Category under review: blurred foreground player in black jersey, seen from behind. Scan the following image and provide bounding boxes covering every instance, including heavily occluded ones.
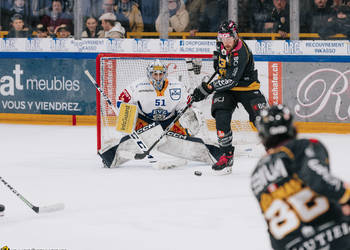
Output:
[251,105,350,250]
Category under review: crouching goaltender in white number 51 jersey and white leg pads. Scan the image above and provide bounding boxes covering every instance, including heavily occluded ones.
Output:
[99,59,218,168]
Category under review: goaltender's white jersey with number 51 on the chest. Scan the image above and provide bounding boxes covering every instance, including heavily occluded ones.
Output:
[119,77,189,121]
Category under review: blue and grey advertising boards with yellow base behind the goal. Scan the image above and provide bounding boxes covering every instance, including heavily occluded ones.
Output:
[0,41,350,133]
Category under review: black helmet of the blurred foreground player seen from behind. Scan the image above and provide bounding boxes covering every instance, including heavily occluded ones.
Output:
[255,104,296,148]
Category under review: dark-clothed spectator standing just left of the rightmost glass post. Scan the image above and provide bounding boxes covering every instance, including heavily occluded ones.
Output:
[272,0,289,38]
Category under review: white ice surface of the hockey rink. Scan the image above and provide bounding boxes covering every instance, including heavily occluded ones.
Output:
[0,124,350,250]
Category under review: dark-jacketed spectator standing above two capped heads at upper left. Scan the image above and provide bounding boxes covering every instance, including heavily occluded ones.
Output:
[41,0,73,34]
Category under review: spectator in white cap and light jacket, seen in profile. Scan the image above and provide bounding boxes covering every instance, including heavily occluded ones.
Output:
[98,13,125,38]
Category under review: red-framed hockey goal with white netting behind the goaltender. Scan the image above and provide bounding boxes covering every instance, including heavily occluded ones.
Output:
[96,53,254,150]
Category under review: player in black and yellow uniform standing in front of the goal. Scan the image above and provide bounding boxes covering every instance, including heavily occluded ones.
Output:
[192,21,266,174]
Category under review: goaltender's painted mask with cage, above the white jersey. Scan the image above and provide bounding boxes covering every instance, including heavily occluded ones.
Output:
[147,59,167,91]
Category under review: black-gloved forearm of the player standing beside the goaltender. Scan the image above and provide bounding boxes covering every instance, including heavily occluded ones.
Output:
[192,75,238,102]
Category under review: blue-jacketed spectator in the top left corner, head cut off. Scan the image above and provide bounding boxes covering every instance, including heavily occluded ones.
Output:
[1,0,35,30]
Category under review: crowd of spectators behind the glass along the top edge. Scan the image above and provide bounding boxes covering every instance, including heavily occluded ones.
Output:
[0,0,350,39]
